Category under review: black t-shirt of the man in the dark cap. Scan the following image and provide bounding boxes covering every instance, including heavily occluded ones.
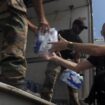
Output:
[59,30,82,59]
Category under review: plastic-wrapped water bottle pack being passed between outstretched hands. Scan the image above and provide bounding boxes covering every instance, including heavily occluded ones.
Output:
[34,28,58,55]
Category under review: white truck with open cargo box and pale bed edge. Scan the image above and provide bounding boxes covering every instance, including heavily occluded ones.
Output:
[0,0,94,105]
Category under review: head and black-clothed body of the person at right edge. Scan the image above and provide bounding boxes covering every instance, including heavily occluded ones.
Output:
[84,24,105,105]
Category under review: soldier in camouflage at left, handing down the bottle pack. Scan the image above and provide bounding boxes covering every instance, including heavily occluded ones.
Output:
[0,0,49,88]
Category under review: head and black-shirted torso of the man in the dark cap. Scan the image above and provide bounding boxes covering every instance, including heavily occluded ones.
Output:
[59,18,87,59]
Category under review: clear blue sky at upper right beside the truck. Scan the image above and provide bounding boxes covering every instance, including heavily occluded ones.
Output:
[92,0,105,38]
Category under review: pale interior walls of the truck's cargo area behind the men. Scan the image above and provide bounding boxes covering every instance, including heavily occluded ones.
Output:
[27,0,93,105]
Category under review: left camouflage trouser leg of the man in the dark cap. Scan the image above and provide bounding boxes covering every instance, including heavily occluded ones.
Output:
[41,61,61,101]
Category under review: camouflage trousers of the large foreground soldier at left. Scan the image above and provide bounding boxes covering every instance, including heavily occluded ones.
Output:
[0,9,28,87]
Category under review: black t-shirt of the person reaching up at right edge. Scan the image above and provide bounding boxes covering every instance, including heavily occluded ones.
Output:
[87,56,105,91]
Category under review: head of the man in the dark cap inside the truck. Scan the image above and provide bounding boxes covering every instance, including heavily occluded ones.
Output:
[72,18,87,34]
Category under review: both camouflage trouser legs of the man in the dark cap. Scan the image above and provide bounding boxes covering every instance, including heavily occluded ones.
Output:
[41,61,79,105]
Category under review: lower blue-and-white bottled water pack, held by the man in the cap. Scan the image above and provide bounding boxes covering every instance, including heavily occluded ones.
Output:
[60,69,83,89]
